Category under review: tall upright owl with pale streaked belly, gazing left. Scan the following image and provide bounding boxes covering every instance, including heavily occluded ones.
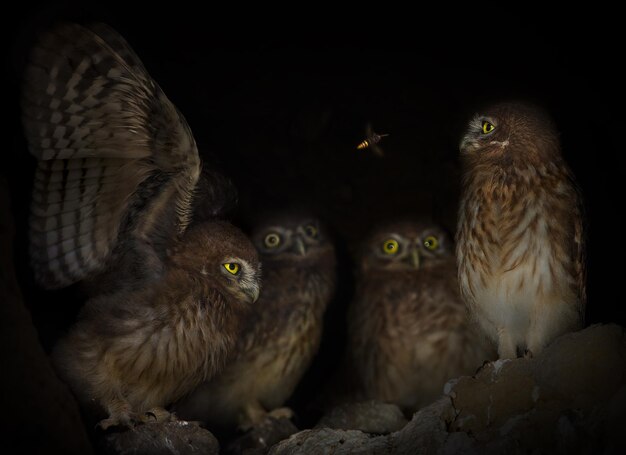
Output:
[456,103,586,358]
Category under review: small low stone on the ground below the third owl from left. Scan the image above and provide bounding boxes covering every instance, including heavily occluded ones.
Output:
[316,401,407,434]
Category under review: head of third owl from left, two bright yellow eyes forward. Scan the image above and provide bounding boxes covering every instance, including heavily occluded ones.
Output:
[360,221,454,272]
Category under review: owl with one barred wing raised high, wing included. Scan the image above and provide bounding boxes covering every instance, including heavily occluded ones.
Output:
[22,24,260,428]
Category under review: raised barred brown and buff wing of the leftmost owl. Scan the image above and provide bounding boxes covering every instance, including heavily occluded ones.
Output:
[22,24,200,288]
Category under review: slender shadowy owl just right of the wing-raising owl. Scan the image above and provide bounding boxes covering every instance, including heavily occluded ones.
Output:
[177,212,335,428]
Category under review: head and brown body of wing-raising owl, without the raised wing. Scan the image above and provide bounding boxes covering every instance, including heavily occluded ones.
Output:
[53,222,259,426]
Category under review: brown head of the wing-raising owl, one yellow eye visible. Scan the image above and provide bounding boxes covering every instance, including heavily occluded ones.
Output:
[170,221,261,303]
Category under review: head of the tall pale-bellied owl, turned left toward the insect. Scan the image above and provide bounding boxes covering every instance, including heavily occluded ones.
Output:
[459,102,559,161]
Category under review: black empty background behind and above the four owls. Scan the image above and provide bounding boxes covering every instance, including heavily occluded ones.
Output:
[2,2,626,434]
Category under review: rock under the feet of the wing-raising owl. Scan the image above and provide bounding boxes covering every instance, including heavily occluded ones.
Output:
[101,420,220,455]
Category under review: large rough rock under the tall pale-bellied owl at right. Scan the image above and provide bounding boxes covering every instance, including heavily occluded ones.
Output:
[449,325,626,452]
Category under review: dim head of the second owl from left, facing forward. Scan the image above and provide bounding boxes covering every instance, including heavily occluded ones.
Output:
[252,212,332,264]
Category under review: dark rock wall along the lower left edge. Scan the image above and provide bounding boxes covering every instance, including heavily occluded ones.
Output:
[0,178,92,455]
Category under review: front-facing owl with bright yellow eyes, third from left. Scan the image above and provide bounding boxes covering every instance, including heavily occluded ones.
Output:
[348,220,495,413]
